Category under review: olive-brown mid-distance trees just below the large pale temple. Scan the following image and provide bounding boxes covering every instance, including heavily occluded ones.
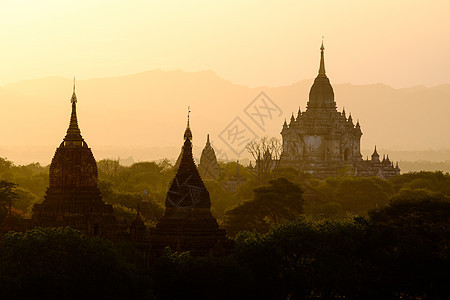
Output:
[222,169,450,235]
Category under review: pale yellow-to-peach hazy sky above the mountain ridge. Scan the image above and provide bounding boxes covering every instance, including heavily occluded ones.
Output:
[0,0,450,87]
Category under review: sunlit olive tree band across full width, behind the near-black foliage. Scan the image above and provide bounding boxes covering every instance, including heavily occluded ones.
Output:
[0,158,450,229]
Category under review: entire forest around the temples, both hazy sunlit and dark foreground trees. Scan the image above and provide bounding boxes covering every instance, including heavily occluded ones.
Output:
[0,158,450,299]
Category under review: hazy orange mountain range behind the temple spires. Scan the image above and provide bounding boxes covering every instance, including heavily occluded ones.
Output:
[0,70,450,164]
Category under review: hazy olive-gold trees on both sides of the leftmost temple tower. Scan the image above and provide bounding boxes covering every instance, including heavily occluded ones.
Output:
[0,158,175,223]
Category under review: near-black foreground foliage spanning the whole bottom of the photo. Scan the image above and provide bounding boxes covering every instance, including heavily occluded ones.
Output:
[0,196,450,299]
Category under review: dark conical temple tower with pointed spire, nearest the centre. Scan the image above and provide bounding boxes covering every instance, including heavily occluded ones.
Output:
[150,117,232,256]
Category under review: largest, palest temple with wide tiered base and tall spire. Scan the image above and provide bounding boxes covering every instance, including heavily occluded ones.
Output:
[280,43,399,178]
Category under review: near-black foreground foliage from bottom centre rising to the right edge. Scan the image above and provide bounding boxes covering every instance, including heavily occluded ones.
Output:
[152,198,450,299]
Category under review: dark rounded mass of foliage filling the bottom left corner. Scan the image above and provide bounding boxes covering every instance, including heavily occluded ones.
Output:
[0,227,152,299]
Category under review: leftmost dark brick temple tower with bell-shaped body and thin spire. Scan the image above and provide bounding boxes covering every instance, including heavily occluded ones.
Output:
[32,83,118,237]
